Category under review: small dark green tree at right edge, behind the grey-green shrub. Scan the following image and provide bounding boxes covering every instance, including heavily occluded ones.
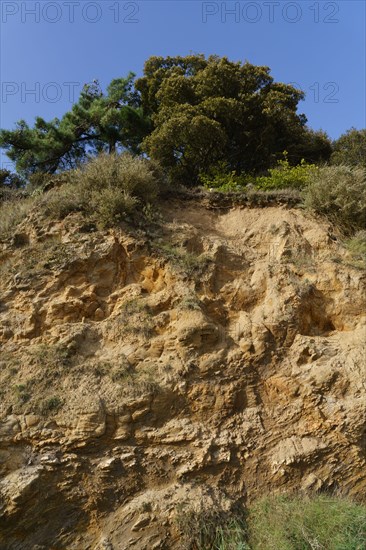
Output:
[331,128,366,168]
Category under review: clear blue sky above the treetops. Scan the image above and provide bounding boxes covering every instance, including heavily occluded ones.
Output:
[0,0,366,168]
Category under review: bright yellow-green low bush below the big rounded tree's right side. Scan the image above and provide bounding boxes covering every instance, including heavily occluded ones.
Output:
[255,151,318,191]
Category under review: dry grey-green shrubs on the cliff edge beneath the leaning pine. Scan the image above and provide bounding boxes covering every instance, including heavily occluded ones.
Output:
[0,152,164,239]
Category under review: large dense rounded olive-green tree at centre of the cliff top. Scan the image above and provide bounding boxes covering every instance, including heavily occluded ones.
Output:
[135,55,331,184]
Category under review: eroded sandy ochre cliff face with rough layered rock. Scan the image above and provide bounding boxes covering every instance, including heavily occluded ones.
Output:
[0,201,366,550]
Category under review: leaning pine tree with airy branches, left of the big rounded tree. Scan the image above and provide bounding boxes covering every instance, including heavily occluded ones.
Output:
[0,73,150,176]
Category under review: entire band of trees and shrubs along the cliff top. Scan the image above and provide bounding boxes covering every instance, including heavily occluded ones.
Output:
[0,54,366,244]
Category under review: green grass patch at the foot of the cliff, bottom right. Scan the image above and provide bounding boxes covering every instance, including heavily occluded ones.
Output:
[178,495,366,550]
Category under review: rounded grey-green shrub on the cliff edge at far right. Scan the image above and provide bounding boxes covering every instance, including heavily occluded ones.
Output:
[304,165,366,234]
